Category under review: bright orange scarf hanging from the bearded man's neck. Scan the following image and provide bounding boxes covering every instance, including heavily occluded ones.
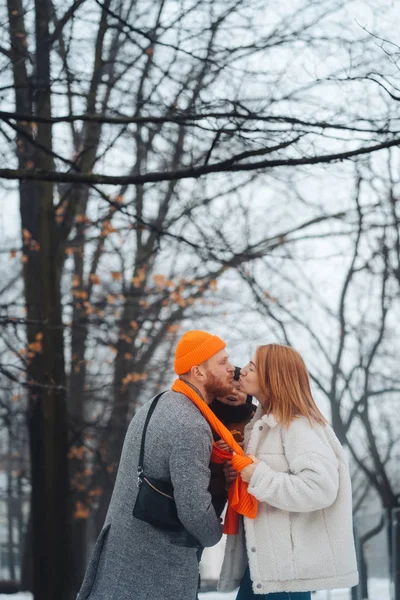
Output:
[172,379,258,534]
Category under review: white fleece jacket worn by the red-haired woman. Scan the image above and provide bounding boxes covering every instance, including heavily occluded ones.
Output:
[219,407,358,594]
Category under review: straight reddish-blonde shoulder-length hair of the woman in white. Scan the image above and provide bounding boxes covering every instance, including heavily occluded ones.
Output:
[255,344,327,426]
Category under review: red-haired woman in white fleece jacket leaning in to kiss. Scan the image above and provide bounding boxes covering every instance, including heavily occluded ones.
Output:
[219,344,358,600]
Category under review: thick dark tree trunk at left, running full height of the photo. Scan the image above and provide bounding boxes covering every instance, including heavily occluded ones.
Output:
[20,0,68,600]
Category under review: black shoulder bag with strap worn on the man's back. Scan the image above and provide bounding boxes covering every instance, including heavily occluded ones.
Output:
[132,392,183,532]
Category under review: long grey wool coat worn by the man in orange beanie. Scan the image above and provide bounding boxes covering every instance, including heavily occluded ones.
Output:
[77,391,222,600]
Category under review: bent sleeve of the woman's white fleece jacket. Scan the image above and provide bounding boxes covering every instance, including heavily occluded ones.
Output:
[248,422,339,512]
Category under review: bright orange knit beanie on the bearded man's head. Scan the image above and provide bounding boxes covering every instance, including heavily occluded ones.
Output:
[174,330,226,375]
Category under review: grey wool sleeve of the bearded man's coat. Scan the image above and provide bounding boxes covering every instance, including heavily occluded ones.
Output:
[170,422,222,547]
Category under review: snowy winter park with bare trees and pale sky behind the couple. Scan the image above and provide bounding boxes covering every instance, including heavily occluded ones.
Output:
[0,0,400,600]
